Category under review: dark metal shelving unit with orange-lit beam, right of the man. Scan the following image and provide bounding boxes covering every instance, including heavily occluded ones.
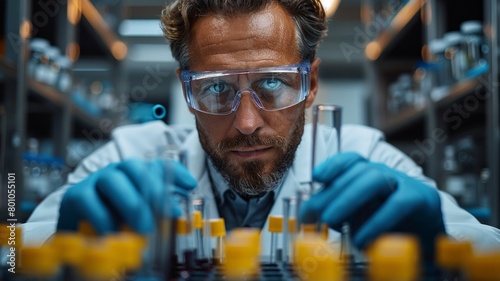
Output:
[365,0,500,226]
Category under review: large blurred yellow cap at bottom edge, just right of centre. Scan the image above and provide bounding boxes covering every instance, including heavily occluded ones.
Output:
[293,232,345,281]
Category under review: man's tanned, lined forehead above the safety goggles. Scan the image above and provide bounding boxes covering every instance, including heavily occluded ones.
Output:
[189,4,296,70]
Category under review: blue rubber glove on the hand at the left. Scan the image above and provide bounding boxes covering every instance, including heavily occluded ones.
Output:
[57,159,197,234]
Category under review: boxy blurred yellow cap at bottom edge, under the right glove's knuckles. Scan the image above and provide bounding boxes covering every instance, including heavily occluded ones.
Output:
[367,234,420,281]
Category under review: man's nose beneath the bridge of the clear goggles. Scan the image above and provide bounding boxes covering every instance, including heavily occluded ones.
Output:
[233,92,264,135]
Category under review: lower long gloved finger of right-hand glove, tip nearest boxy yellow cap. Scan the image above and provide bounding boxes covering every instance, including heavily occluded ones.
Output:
[353,186,427,249]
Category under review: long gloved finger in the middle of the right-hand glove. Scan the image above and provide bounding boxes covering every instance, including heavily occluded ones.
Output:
[320,167,396,229]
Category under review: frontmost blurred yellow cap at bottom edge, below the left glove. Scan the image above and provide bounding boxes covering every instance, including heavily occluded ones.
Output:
[78,240,119,280]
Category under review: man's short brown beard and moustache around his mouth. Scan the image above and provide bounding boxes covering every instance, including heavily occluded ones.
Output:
[196,111,305,198]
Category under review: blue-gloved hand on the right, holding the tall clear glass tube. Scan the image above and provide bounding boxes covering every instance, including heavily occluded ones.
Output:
[301,153,445,259]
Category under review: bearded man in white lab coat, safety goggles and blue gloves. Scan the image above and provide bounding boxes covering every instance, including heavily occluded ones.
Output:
[25,0,500,258]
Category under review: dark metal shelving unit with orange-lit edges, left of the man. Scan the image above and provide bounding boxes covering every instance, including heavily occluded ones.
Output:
[0,0,123,219]
